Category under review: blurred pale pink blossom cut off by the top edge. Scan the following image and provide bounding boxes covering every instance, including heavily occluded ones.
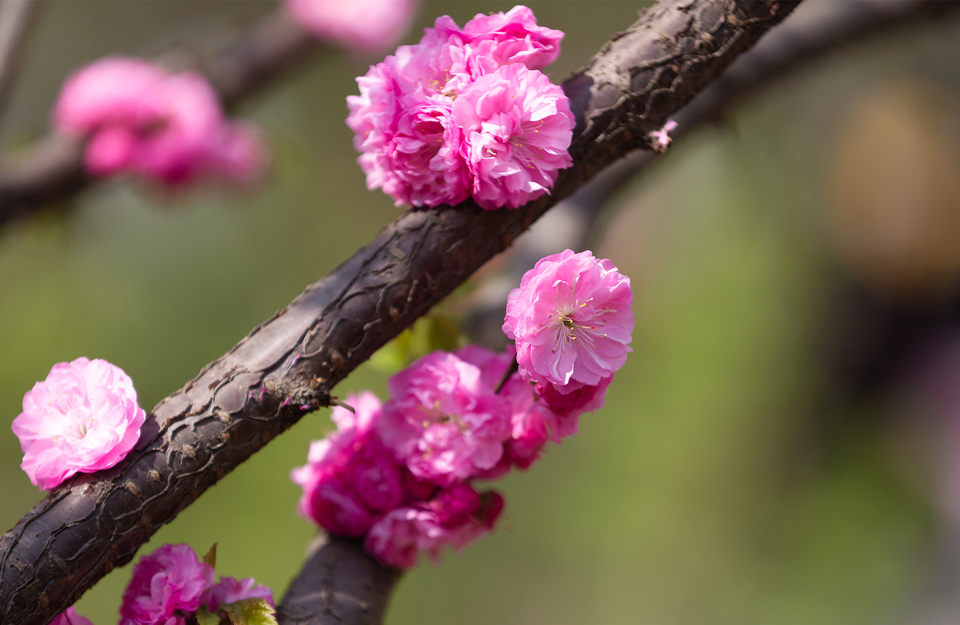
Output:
[286,0,417,52]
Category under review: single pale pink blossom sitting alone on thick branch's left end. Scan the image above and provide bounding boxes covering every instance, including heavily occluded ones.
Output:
[12,358,146,490]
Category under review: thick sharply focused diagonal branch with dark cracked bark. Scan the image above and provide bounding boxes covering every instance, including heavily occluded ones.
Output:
[0,0,796,624]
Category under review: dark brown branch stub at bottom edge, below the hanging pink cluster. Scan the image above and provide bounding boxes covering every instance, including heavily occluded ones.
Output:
[277,535,401,625]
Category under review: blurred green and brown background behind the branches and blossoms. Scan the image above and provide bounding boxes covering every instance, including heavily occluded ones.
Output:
[0,0,960,625]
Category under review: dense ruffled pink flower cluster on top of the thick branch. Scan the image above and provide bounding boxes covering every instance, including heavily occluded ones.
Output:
[347,6,574,209]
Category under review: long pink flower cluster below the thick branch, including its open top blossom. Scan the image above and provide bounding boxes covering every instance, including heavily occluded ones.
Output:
[291,250,633,568]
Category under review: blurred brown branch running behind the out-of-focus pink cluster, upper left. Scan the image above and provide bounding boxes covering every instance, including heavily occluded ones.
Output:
[0,6,322,226]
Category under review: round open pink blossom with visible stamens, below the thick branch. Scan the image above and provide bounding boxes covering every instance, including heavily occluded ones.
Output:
[503,250,634,394]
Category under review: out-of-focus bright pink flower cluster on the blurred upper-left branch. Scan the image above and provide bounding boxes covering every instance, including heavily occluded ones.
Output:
[53,57,265,185]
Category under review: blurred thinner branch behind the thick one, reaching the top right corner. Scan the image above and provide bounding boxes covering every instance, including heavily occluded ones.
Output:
[462,0,960,349]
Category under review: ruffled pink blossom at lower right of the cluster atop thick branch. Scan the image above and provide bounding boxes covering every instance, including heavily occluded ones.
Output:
[453,63,574,209]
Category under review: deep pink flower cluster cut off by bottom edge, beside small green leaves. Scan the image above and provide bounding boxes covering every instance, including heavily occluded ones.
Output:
[120,544,274,625]
